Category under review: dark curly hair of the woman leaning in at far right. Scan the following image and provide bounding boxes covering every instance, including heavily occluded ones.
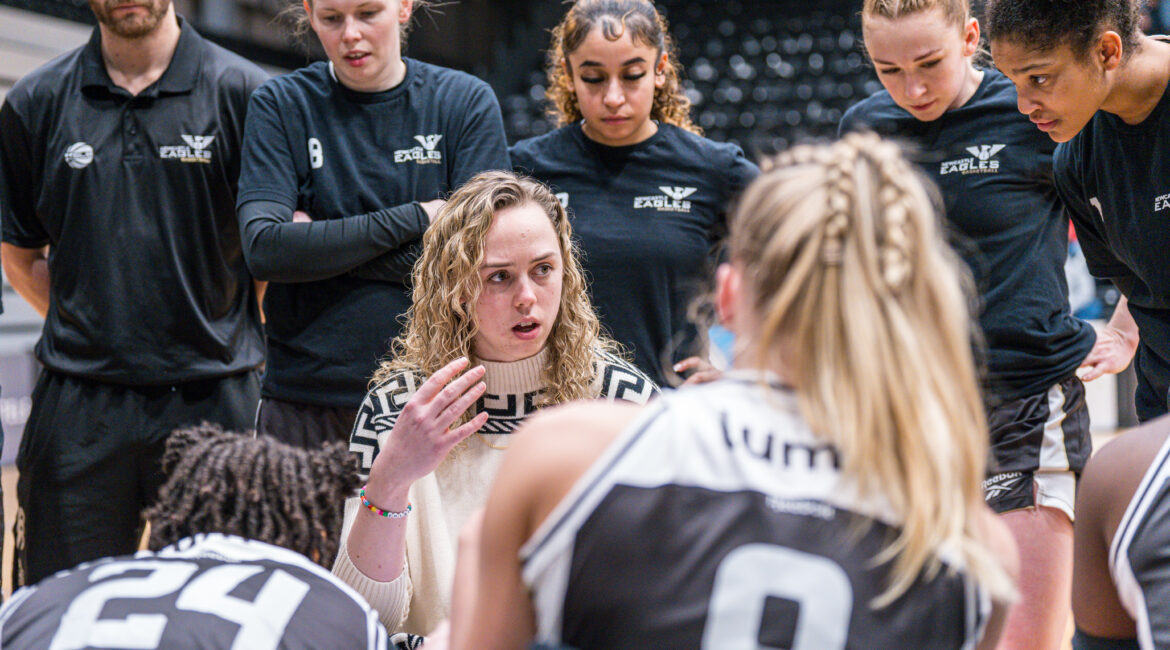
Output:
[984,0,1143,57]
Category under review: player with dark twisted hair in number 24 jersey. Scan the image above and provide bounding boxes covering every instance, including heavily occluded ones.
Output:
[0,426,387,650]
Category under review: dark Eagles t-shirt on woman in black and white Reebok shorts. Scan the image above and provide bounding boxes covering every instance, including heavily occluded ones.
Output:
[840,70,1096,403]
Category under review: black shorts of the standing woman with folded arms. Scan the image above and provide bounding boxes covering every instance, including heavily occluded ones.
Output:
[256,397,358,449]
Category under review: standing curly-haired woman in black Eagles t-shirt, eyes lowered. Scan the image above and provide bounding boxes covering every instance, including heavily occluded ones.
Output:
[510,0,759,383]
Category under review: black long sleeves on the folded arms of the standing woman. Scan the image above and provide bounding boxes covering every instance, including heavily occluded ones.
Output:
[238,200,431,283]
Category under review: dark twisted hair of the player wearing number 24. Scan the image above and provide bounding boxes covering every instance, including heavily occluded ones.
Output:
[145,422,360,568]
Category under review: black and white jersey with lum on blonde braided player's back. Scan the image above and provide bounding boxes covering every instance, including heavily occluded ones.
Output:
[521,373,990,650]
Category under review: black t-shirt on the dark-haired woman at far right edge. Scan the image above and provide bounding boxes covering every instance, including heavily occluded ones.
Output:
[1055,81,1170,421]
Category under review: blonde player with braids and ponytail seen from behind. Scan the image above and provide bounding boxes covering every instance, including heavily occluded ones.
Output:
[452,133,1016,649]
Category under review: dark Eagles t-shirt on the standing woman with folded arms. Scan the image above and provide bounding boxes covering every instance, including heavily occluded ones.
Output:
[239,58,510,408]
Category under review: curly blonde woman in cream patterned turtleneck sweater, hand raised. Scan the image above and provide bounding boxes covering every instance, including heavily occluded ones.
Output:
[333,172,656,634]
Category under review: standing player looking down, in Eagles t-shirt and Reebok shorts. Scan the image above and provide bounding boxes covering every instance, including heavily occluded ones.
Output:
[840,0,1095,648]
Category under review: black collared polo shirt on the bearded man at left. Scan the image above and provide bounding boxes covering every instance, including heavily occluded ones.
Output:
[0,19,267,385]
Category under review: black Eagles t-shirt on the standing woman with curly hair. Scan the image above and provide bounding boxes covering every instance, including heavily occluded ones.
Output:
[511,124,759,386]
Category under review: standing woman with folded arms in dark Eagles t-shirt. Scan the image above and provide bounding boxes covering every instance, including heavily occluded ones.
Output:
[238,0,510,445]
